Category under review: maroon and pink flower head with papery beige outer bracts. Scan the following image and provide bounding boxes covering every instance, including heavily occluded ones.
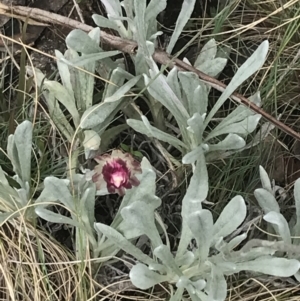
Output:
[92,150,142,196]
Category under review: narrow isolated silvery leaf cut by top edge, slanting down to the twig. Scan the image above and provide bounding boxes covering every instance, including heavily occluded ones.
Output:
[166,0,196,53]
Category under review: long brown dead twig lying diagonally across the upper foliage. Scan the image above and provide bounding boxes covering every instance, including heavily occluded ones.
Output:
[0,3,300,141]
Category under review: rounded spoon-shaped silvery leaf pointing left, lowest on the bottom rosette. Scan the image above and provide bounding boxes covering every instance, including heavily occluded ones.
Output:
[129,263,168,290]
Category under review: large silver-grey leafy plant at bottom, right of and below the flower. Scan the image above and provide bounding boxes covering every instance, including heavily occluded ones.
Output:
[95,154,300,301]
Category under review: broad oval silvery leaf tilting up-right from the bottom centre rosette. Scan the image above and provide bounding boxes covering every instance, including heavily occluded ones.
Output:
[213,195,247,242]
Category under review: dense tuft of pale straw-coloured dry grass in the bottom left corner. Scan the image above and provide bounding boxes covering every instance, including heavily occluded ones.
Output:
[0,219,85,301]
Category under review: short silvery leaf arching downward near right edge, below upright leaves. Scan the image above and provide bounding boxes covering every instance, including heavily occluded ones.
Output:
[264,211,291,244]
